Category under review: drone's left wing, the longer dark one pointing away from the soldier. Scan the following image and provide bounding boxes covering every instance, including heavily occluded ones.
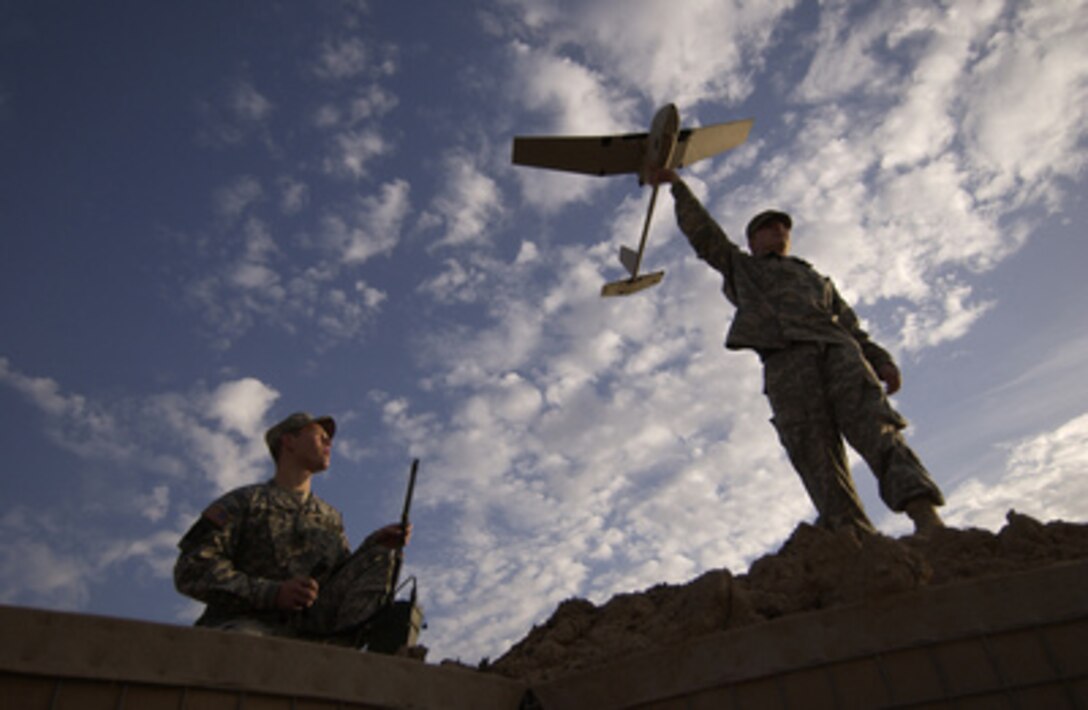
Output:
[514,133,647,175]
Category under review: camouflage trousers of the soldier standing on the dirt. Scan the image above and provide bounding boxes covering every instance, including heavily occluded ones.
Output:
[763,342,944,530]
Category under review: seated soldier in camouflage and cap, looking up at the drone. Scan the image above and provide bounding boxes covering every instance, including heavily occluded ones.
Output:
[174,412,411,637]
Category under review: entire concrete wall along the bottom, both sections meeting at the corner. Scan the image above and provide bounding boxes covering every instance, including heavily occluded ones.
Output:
[0,562,1088,710]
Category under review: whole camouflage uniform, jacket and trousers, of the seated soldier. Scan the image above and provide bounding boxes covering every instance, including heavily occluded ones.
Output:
[174,482,393,636]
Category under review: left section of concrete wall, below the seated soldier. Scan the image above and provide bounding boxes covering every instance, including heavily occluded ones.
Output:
[0,607,524,710]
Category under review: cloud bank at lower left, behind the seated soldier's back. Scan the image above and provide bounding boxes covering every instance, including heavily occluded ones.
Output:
[0,359,280,609]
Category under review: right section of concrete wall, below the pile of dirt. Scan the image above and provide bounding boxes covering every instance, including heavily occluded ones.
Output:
[533,562,1088,710]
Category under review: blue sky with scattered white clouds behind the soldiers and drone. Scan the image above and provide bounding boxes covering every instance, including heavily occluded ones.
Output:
[0,0,1088,664]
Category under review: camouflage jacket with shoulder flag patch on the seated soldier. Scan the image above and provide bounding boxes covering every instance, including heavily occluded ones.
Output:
[174,482,350,623]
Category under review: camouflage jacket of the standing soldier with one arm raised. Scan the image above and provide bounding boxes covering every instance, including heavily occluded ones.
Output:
[672,179,892,369]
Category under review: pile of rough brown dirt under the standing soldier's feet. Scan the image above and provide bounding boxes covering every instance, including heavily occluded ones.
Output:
[481,511,1088,683]
